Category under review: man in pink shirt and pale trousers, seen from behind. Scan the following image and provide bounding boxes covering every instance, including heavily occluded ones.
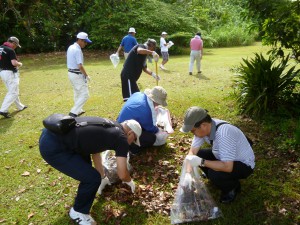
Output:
[189,32,203,75]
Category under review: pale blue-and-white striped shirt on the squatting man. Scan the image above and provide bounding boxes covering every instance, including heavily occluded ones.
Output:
[192,119,255,169]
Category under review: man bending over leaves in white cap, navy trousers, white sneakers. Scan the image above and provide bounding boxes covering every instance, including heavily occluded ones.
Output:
[39,117,142,225]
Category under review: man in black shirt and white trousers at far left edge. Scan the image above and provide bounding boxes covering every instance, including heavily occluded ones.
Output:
[0,37,27,118]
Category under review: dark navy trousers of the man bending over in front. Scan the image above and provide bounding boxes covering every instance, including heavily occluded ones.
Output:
[39,129,101,214]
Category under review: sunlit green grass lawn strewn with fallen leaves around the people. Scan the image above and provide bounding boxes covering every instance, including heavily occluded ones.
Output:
[0,43,300,225]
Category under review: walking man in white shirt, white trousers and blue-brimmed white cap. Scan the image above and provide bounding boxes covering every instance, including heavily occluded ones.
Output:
[67,32,92,117]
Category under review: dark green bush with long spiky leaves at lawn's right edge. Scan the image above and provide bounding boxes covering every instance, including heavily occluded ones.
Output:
[234,53,300,117]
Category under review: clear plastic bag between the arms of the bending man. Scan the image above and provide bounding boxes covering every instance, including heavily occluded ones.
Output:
[101,150,132,184]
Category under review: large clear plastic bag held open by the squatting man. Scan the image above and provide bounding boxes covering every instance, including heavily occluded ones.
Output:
[170,161,222,224]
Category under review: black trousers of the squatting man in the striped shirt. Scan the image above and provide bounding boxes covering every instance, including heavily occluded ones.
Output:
[197,149,253,193]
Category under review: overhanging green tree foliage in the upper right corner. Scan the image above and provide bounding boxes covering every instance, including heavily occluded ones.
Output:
[245,0,300,60]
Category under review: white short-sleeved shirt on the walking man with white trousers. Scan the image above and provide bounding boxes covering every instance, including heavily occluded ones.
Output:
[67,42,83,70]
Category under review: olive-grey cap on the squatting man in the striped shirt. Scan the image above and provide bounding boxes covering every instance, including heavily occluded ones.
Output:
[180,106,207,133]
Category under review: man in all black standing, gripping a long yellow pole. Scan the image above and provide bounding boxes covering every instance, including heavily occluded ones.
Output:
[121,39,160,102]
